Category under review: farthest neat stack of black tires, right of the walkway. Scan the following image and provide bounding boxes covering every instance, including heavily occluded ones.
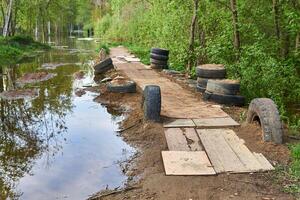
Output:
[150,48,170,69]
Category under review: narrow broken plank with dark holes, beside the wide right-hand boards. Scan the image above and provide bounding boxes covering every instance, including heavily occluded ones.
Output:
[183,128,204,151]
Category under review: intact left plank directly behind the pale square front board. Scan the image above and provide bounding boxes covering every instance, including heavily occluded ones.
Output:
[165,128,191,151]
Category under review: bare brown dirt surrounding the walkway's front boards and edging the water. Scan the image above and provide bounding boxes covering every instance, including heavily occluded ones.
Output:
[91,69,293,200]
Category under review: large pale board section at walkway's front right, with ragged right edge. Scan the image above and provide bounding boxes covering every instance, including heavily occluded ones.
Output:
[197,129,274,173]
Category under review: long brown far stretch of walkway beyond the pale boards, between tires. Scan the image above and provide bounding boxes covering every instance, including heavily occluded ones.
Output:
[111,47,229,119]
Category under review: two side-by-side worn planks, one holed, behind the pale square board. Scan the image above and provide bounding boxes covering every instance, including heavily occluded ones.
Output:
[165,128,203,151]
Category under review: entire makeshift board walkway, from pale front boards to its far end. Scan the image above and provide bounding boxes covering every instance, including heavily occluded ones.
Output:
[111,47,274,175]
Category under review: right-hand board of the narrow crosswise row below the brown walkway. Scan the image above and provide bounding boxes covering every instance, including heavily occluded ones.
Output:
[193,117,240,128]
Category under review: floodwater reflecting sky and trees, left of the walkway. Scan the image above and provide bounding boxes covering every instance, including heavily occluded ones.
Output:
[0,39,134,200]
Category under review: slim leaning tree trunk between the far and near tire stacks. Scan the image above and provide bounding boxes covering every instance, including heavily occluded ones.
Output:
[187,0,199,73]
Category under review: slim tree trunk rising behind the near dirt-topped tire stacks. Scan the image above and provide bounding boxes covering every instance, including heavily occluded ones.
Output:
[230,0,241,57]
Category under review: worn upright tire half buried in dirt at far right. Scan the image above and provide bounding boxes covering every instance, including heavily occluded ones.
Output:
[247,98,283,144]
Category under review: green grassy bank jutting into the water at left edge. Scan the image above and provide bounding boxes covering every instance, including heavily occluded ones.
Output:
[0,36,50,65]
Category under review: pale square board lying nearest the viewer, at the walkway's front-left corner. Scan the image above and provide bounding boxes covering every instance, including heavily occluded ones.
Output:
[162,151,216,175]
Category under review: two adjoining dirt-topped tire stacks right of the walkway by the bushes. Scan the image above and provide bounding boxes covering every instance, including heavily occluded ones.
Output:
[196,64,245,106]
